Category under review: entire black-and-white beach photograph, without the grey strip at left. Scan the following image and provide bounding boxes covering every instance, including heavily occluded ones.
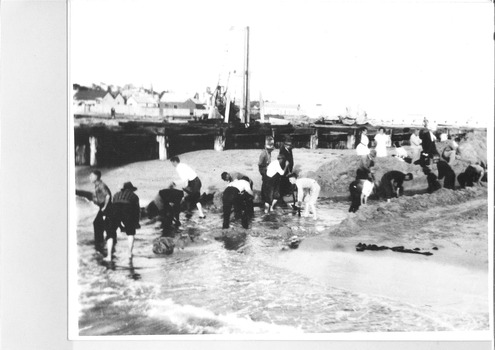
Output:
[67,0,494,340]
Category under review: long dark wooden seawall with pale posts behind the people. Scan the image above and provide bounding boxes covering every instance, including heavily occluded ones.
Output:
[74,120,476,166]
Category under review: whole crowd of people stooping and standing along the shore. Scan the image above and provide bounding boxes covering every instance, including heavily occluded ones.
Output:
[90,127,485,261]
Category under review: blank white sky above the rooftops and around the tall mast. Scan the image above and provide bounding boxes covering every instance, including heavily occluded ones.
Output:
[70,0,494,122]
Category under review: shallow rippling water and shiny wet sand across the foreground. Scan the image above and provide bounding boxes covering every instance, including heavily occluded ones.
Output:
[77,196,488,335]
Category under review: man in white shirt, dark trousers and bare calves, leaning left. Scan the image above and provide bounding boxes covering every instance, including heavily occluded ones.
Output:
[170,157,205,219]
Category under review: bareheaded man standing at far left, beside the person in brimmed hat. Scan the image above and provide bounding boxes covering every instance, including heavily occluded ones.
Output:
[89,170,112,254]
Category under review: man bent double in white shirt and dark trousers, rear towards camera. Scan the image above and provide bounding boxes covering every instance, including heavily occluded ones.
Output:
[222,179,253,229]
